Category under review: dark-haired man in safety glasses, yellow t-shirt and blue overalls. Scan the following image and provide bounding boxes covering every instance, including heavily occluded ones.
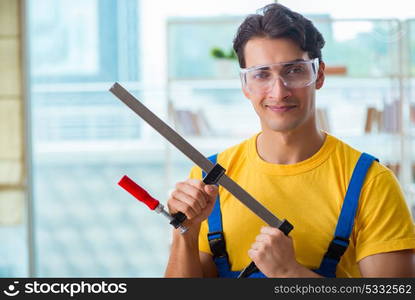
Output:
[165,4,415,277]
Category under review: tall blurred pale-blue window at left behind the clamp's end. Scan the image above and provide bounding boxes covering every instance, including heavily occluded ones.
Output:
[27,0,158,277]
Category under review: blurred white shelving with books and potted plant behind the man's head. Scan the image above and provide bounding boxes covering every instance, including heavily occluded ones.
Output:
[166,15,415,213]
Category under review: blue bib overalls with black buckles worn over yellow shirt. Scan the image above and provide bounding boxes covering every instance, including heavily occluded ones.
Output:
[202,153,379,278]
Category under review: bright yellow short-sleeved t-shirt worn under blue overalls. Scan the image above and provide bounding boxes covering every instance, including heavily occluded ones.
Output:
[190,134,415,277]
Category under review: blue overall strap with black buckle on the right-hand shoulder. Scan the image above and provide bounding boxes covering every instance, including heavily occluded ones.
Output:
[314,153,379,277]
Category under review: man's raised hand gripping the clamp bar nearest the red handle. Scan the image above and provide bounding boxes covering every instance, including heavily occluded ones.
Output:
[167,179,218,229]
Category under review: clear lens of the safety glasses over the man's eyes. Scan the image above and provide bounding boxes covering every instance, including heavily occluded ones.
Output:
[241,58,318,94]
